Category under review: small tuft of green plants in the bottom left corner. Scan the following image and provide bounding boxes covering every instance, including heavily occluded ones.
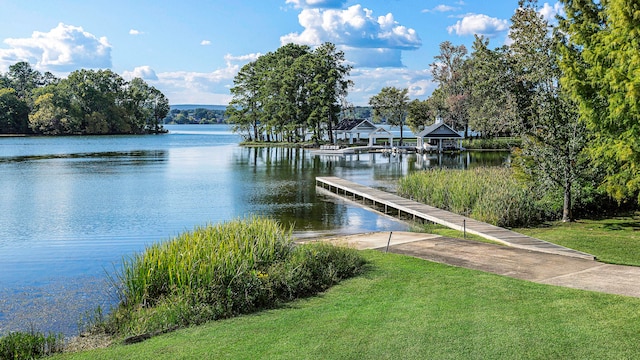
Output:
[0,330,64,360]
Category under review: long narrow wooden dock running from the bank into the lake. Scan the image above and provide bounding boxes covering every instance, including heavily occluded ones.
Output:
[316,177,595,260]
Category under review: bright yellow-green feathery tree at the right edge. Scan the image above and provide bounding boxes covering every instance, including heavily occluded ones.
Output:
[560,0,640,202]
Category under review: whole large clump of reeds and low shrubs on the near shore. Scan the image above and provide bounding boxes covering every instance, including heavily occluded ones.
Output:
[108,217,364,335]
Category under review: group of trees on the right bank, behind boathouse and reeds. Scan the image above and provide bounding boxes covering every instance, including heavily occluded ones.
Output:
[362,0,640,221]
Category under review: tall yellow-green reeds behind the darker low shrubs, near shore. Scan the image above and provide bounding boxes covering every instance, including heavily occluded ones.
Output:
[120,218,292,306]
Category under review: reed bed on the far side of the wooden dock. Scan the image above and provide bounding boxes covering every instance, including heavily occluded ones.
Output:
[398,167,541,227]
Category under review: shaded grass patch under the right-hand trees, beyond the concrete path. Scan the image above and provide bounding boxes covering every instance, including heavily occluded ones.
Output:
[514,213,640,266]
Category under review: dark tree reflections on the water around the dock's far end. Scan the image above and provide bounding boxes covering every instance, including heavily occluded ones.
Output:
[228,147,508,232]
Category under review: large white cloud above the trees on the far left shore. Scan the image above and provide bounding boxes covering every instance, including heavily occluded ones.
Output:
[0,23,111,73]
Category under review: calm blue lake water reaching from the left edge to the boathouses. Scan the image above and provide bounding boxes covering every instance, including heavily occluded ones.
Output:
[0,125,504,335]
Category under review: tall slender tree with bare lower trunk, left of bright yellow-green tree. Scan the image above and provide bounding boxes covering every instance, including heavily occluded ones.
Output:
[510,0,587,221]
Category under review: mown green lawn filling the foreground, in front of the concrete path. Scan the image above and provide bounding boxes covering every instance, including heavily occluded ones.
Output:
[54,251,640,359]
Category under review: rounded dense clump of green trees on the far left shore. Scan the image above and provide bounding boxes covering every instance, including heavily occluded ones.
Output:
[0,62,169,135]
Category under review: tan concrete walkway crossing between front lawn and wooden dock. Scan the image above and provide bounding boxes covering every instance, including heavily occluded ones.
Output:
[305,232,640,297]
